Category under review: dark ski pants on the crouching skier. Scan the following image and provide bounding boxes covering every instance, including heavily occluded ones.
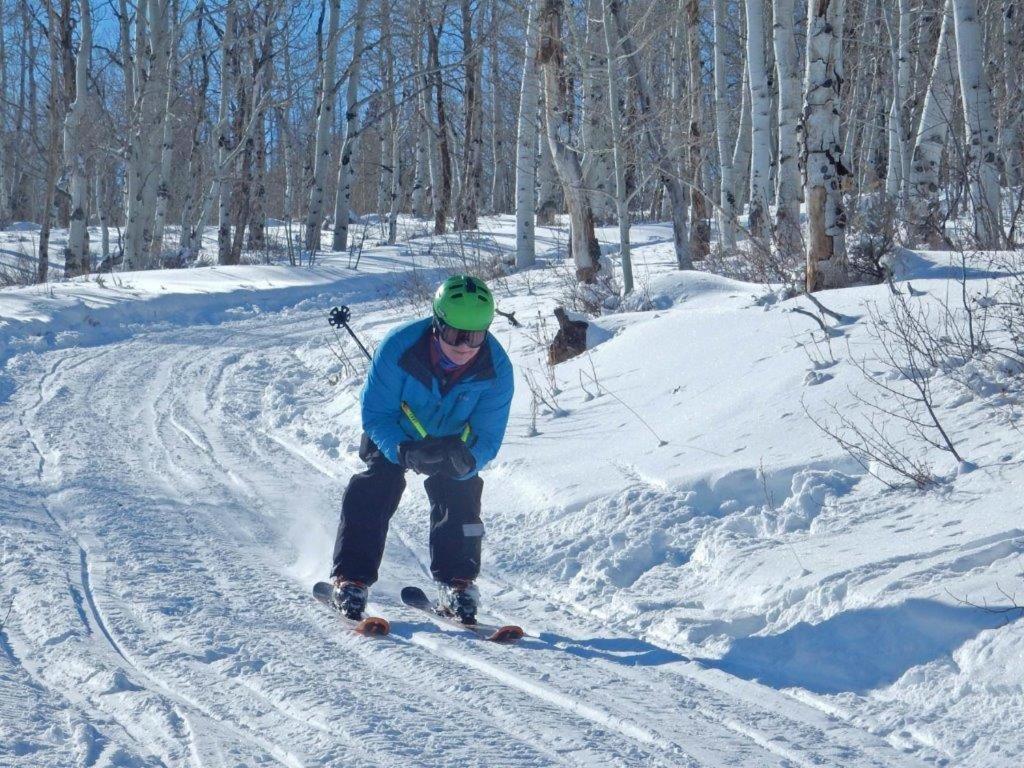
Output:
[331,434,483,585]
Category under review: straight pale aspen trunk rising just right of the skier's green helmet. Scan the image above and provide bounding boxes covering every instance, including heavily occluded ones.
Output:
[515,0,540,269]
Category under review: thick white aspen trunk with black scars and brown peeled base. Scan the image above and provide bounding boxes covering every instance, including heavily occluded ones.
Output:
[804,0,849,293]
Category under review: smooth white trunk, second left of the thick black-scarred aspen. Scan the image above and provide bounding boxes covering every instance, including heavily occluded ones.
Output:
[745,0,771,244]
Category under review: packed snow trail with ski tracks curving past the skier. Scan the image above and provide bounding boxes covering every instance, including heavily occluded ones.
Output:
[0,286,937,768]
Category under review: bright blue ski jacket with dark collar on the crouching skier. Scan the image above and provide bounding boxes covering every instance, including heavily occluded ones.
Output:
[360,317,514,480]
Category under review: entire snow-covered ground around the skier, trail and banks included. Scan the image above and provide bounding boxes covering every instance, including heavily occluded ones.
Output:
[0,218,1024,767]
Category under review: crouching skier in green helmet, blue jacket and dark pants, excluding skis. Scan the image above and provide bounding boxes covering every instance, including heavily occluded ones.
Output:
[331,274,513,624]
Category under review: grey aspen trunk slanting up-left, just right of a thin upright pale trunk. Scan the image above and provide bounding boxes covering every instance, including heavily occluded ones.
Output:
[608,0,693,269]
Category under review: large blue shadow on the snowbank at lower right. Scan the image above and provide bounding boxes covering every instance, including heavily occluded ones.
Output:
[700,600,1021,693]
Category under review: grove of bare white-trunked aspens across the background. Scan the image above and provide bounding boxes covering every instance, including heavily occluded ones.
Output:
[0,0,1024,291]
